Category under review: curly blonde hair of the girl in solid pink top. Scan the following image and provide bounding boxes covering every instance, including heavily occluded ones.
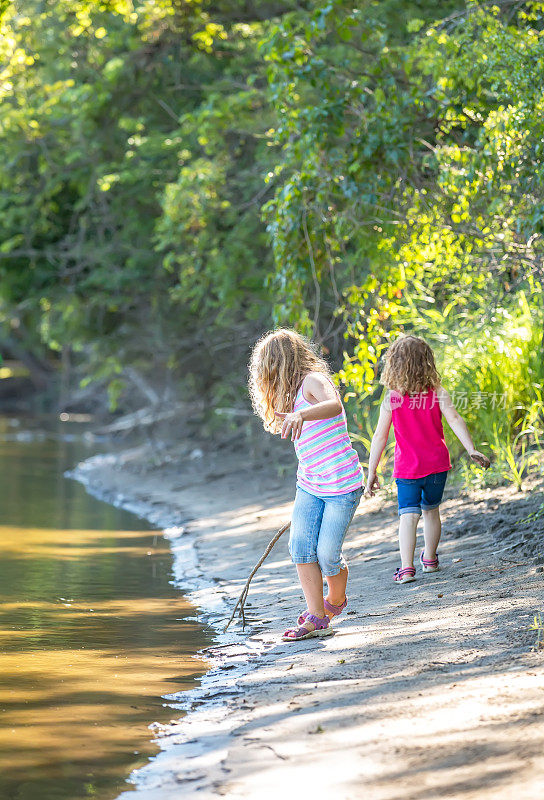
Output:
[380,336,440,395]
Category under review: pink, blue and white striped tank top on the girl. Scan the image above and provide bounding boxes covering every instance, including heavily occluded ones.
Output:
[293,381,363,497]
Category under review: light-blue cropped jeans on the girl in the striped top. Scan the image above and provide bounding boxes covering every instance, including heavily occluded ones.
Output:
[289,486,363,577]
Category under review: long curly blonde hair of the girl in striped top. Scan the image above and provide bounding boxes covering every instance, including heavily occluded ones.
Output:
[249,328,331,433]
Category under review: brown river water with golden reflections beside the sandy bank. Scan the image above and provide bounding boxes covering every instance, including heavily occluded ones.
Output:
[0,417,211,800]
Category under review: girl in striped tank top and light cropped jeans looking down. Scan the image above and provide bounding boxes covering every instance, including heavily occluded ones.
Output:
[249,328,363,642]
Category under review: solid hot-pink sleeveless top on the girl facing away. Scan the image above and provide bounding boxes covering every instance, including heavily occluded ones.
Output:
[389,390,451,478]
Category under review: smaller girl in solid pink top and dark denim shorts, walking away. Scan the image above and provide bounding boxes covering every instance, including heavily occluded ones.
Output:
[366,336,489,583]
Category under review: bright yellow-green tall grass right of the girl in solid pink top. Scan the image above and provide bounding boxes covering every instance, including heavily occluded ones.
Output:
[437,292,544,489]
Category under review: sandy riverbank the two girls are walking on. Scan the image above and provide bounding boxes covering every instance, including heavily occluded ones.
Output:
[72,440,544,800]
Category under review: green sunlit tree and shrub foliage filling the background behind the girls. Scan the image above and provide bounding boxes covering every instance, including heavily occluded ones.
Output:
[0,0,544,482]
